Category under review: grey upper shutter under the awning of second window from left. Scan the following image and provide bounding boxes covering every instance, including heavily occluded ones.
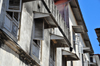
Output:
[34,19,44,40]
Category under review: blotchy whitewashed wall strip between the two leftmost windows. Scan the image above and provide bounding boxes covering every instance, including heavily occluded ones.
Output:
[19,2,33,54]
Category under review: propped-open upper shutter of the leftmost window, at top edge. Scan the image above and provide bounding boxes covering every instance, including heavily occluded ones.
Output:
[7,0,22,12]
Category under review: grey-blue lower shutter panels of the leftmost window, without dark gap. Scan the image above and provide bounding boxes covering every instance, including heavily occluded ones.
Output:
[4,14,19,38]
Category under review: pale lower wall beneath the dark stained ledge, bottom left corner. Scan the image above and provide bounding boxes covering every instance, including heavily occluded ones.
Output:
[0,45,29,66]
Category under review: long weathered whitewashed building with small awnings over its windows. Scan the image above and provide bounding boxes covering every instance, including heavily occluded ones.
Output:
[0,0,97,66]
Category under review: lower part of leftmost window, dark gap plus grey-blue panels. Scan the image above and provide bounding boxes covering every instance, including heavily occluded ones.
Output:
[4,11,20,38]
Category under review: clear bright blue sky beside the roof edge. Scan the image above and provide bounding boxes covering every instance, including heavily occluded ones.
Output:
[78,0,100,54]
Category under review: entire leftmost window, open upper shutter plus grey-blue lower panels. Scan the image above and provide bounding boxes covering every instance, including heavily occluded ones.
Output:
[4,0,22,38]
